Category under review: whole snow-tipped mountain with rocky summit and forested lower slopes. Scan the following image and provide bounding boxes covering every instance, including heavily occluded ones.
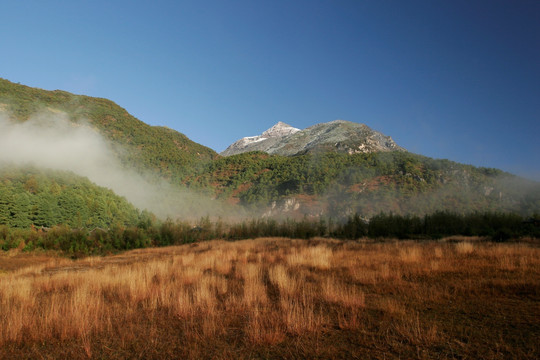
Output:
[212,120,540,219]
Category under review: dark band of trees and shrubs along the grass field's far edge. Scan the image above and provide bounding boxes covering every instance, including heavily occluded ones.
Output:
[0,212,540,257]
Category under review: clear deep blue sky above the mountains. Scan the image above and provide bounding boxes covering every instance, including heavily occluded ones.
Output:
[0,0,540,180]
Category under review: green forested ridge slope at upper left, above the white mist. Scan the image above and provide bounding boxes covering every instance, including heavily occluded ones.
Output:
[0,79,217,179]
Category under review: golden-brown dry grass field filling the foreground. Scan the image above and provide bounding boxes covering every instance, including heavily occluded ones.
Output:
[0,238,540,359]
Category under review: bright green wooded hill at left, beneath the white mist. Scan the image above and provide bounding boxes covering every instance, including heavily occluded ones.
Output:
[0,165,139,228]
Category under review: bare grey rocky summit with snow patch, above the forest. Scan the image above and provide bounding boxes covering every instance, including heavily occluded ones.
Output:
[220,120,405,156]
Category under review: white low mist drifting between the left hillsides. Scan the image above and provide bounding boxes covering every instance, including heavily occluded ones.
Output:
[0,111,243,220]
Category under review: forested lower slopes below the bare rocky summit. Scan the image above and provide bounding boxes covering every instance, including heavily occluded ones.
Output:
[186,151,540,218]
